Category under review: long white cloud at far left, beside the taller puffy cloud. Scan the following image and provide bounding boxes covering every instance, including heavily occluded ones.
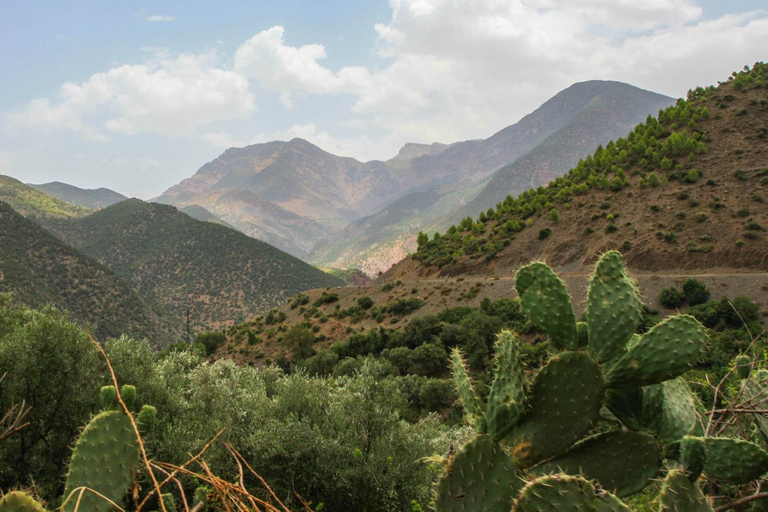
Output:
[5,54,255,141]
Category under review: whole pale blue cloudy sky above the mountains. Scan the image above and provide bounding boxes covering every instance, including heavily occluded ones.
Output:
[0,0,768,199]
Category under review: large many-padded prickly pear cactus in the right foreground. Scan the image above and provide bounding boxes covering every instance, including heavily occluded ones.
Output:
[436,251,712,511]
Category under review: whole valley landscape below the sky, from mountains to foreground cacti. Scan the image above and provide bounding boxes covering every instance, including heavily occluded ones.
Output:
[0,62,768,512]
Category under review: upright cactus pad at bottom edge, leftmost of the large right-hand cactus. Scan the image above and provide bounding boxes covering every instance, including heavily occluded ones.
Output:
[435,435,523,512]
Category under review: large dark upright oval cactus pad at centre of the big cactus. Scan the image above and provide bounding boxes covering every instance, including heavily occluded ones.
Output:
[508,352,604,468]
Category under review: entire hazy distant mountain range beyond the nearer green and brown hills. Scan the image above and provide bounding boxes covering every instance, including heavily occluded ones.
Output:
[157,81,673,274]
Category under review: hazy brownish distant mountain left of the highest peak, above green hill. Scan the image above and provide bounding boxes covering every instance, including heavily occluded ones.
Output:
[156,139,401,255]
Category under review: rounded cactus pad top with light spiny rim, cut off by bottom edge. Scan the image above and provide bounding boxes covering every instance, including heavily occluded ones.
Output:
[512,474,629,512]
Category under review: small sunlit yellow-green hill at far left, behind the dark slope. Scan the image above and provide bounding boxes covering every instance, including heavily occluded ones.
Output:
[0,175,91,220]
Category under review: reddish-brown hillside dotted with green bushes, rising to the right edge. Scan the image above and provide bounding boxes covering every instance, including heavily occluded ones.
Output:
[208,64,768,372]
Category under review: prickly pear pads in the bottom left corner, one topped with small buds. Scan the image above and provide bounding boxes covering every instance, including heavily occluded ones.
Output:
[0,385,157,512]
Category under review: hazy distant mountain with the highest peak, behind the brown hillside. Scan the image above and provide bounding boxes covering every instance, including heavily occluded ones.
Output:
[308,81,674,275]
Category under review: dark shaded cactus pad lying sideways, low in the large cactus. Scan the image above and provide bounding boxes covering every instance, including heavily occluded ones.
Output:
[535,431,661,497]
